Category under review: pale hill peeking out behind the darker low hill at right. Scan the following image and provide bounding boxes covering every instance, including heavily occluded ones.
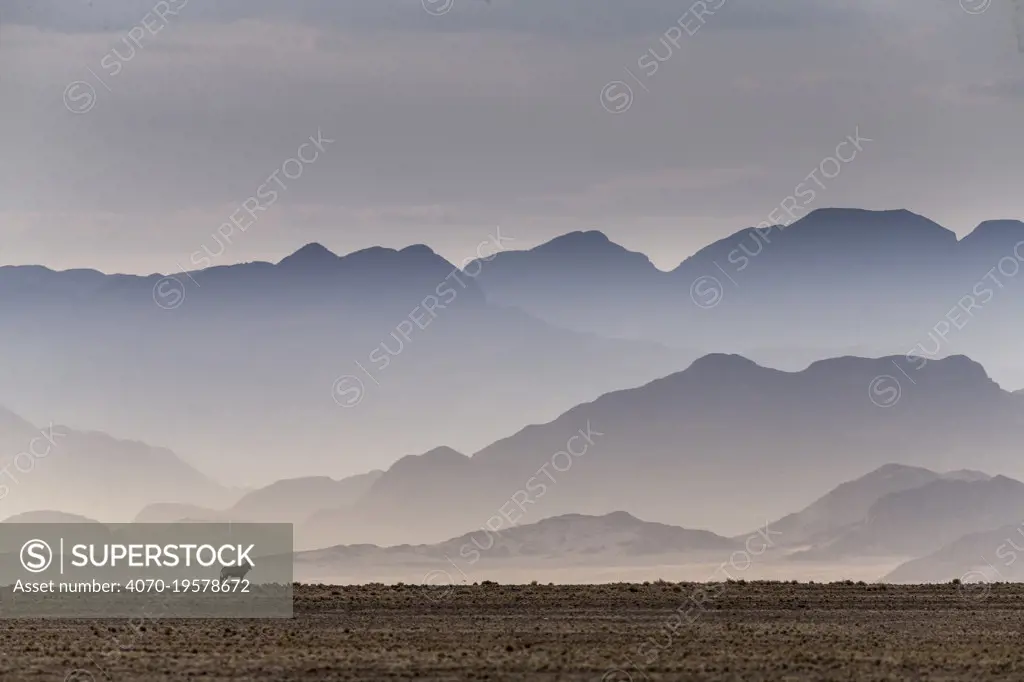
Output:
[769,464,988,546]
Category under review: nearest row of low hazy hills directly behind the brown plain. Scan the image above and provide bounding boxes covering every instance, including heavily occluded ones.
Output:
[16,450,1024,589]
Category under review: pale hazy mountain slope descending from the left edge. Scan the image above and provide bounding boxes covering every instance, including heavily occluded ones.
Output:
[0,409,227,522]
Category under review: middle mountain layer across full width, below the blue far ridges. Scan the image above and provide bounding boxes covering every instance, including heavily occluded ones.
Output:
[5,346,1024,540]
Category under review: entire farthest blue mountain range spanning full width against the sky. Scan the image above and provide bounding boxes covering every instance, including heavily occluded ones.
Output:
[0,209,1024,486]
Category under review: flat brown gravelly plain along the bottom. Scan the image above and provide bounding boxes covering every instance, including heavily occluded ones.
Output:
[0,583,1024,682]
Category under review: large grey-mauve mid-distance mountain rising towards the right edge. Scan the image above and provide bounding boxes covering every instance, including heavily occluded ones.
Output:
[303,355,1024,544]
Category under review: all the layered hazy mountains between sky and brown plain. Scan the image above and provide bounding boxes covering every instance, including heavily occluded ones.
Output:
[6,209,1024,574]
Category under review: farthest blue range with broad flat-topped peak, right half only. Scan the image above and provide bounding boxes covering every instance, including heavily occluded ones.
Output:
[468,208,1024,374]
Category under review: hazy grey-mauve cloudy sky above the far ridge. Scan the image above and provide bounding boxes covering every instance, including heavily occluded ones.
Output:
[0,0,1024,272]
